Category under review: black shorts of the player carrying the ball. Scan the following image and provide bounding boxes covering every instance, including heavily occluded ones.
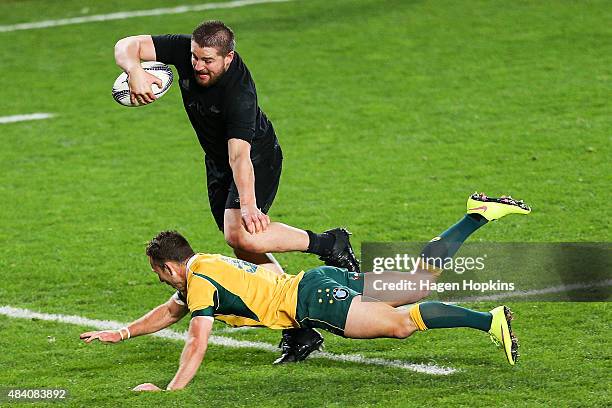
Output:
[204,145,283,231]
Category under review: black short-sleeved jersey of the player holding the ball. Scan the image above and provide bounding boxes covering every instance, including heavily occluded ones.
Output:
[152,34,278,166]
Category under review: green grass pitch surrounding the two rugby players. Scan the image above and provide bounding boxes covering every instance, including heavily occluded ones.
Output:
[0,0,612,407]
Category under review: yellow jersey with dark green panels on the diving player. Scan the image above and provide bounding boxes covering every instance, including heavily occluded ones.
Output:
[186,254,304,329]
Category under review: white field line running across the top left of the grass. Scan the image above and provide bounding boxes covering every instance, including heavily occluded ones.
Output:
[0,0,292,33]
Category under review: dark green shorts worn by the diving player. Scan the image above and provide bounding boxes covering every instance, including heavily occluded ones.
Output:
[296,266,363,336]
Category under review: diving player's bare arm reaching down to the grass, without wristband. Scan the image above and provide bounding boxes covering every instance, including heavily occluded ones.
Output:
[133,316,213,391]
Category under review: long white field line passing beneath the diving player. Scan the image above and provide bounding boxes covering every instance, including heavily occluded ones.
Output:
[0,306,457,375]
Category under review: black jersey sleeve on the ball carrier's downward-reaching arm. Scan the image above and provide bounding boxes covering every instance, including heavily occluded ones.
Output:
[225,90,257,143]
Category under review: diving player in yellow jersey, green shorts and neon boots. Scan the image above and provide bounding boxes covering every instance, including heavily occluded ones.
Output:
[81,194,531,391]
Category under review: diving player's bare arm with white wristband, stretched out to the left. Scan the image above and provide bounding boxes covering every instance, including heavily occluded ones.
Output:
[80,296,189,343]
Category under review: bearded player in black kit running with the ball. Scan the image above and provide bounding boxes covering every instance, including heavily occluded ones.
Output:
[115,21,359,363]
